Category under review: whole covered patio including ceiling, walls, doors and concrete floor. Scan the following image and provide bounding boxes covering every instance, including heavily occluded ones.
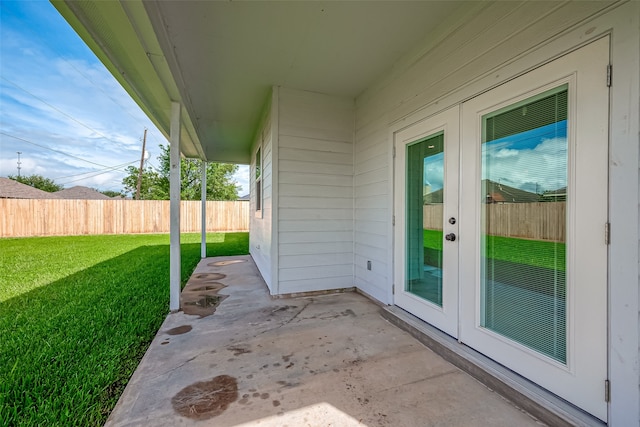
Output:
[53,0,640,426]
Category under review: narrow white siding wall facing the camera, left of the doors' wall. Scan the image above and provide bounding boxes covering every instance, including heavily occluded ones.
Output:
[276,88,354,294]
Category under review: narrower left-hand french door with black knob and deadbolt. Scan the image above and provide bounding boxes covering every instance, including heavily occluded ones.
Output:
[394,106,460,337]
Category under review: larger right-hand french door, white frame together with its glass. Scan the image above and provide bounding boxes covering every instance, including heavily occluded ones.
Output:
[460,37,609,422]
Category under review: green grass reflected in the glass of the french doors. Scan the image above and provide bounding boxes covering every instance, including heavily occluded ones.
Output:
[423,230,565,271]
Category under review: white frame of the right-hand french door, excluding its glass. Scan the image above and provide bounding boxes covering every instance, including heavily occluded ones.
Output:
[459,38,609,421]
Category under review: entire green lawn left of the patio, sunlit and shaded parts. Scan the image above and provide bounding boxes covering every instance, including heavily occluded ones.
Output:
[0,233,249,426]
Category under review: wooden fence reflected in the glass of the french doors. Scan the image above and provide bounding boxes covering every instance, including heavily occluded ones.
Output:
[423,202,567,242]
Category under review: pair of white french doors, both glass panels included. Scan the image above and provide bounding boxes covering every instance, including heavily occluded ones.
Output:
[394,38,609,421]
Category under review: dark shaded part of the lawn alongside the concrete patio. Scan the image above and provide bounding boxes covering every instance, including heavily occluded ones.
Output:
[0,234,248,425]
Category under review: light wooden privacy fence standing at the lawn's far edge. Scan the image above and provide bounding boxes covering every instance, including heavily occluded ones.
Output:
[0,199,249,237]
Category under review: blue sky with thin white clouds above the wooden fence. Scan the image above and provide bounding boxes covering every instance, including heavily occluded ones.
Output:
[0,0,249,196]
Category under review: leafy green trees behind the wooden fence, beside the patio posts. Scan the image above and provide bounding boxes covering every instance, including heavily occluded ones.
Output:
[122,144,239,200]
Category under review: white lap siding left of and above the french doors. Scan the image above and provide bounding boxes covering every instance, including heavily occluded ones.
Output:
[354,2,607,302]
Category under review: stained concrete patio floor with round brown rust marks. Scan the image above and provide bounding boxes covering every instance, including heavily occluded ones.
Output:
[106,256,541,427]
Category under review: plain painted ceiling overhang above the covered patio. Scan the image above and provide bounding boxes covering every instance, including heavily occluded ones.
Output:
[52,0,478,164]
